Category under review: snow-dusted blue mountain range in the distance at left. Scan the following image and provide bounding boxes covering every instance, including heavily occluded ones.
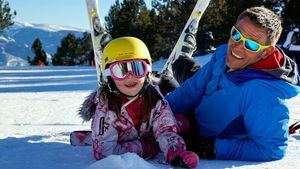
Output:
[0,21,87,66]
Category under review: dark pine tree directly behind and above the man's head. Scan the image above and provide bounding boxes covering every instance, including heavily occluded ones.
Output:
[197,0,285,54]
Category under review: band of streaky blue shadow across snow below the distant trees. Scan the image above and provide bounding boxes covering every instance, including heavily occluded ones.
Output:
[0,66,97,93]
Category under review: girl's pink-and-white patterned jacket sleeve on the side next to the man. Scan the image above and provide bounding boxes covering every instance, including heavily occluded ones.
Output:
[150,100,185,157]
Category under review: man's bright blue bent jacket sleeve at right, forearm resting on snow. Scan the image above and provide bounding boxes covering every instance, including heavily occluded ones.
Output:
[215,86,289,161]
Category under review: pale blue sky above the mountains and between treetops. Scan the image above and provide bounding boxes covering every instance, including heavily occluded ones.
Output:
[5,0,151,29]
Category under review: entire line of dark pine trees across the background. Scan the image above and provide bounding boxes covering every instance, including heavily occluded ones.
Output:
[0,0,300,65]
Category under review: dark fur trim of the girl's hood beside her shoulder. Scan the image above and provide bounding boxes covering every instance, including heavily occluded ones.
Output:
[78,90,97,121]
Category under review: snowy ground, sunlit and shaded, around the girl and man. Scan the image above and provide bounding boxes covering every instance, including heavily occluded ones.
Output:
[0,59,300,169]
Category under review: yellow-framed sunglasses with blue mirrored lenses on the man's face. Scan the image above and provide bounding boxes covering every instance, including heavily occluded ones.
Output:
[230,26,271,52]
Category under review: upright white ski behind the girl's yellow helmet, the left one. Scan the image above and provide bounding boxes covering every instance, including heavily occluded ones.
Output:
[85,0,112,85]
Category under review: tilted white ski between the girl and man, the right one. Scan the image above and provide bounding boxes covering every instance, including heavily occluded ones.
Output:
[160,0,210,76]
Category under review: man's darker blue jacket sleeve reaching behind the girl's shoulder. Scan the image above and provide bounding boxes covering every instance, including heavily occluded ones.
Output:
[166,54,215,114]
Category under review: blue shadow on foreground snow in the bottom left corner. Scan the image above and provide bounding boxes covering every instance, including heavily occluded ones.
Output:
[0,133,95,169]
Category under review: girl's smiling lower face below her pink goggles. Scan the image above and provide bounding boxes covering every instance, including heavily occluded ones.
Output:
[113,74,145,97]
